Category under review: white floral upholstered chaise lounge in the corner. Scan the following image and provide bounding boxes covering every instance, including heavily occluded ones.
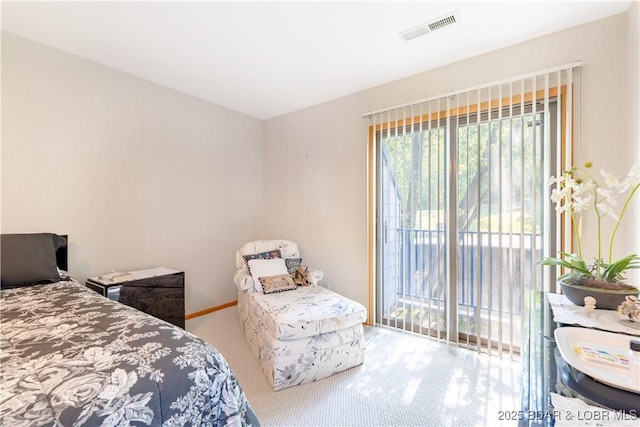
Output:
[234,240,366,390]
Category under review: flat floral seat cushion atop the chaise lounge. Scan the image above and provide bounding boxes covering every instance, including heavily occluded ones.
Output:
[247,286,367,340]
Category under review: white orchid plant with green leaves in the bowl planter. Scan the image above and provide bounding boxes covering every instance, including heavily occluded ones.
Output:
[540,162,640,283]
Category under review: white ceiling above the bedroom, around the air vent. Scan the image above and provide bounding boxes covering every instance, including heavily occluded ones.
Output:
[2,0,637,119]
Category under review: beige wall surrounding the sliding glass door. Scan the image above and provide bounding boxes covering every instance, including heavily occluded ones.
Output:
[264,11,638,310]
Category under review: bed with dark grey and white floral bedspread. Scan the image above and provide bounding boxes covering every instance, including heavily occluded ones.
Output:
[0,233,259,426]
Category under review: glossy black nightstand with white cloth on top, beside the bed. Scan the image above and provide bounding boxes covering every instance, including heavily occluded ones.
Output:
[86,267,185,329]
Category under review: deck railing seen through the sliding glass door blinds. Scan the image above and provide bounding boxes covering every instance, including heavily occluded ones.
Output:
[384,229,541,315]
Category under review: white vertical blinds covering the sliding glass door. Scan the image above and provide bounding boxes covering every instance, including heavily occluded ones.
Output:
[364,63,581,356]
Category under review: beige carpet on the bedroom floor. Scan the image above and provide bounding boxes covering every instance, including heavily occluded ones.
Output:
[187,307,520,427]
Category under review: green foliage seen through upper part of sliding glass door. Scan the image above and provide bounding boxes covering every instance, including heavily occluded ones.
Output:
[382,111,543,233]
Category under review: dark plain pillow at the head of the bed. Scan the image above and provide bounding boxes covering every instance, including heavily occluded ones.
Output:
[0,233,66,289]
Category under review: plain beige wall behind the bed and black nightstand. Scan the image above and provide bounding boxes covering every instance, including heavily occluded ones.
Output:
[1,33,262,313]
